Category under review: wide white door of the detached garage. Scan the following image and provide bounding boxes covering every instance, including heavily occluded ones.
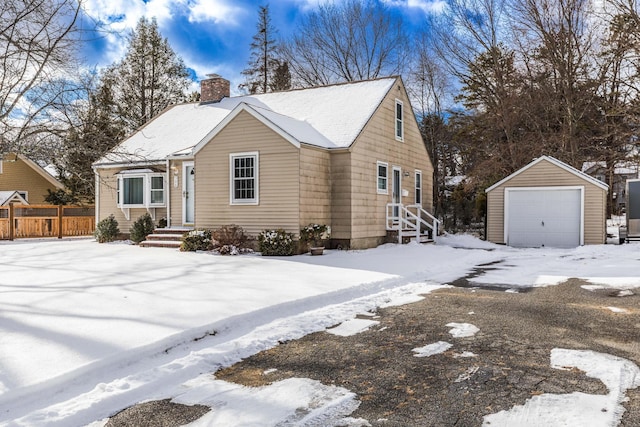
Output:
[505,188,582,248]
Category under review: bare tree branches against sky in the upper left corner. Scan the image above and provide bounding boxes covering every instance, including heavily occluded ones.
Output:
[0,0,81,154]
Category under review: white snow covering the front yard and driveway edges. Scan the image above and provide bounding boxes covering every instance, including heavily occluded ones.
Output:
[0,236,640,426]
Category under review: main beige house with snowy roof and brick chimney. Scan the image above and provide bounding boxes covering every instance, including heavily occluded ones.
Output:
[93,75,433,248]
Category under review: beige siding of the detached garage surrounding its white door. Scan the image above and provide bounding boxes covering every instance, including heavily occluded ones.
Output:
[487,160,606,245]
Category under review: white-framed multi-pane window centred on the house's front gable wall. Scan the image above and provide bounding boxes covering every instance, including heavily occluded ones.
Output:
[229,152,259,205]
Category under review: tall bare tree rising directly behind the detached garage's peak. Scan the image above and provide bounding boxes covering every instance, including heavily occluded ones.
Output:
[514,0,597,166]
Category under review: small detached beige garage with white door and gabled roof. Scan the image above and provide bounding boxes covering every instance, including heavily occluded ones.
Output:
[486,156,608,248]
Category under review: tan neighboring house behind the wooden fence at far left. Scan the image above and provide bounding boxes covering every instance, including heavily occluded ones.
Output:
[0,154,64,205]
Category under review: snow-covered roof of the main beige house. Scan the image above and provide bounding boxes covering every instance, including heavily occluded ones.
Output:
[94,77,396,166]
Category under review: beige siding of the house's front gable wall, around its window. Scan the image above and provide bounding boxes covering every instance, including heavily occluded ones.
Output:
[195,112,300,235]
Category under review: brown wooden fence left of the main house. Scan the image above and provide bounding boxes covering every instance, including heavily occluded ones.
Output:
[0,204,96,240]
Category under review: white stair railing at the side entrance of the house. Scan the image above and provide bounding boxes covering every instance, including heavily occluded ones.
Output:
[386,203,440,243]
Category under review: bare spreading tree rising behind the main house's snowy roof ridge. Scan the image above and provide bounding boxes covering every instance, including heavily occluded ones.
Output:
[283,0,408,86]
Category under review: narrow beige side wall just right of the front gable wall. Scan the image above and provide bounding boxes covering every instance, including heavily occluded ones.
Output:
[300,145,331,227]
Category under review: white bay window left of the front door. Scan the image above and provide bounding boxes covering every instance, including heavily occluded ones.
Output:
[116,169,165,208]
